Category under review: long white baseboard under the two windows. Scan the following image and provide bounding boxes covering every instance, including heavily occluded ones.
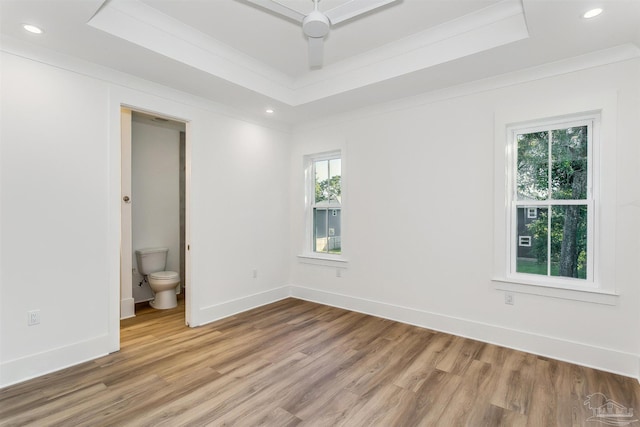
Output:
[291,286,640,381]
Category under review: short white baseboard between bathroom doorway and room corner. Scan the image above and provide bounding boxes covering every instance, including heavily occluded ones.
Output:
[195,286,291,326]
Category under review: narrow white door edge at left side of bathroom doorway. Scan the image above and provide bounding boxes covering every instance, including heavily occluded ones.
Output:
[120,108,135,319]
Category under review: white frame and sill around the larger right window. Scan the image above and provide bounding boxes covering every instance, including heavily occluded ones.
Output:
[490,92,620,306]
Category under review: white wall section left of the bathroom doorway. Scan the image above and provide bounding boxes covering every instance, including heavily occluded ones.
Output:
[0,51,115,385]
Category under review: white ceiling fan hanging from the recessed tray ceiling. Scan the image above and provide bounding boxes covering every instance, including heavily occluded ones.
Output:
[245,0,398,68]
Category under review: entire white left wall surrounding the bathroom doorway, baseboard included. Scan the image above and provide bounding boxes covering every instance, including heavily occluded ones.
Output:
[0,46,290,387]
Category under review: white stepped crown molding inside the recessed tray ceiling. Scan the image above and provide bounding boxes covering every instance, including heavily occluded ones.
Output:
[89,0,529,106]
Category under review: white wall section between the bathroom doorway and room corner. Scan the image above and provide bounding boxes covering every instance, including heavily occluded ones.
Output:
[187,115,290,324]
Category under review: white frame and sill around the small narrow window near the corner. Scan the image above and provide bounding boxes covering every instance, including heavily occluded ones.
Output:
[298,149,347,268]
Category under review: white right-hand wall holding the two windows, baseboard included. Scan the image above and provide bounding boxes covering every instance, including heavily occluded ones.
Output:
[291,60,640,377]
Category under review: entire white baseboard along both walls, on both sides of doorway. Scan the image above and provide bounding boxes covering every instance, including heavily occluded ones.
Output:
[0,286,640,388]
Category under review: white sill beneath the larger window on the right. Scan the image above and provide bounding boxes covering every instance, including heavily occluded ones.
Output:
[492,278,620,305]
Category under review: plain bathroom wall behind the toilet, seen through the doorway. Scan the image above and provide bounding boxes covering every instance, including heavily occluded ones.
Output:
[131,112,184,302]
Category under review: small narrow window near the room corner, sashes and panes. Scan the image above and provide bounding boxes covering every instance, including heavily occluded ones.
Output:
[308,152,342,255]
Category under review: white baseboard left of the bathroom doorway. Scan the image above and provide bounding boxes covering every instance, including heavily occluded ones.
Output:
[0,335,110,388]
